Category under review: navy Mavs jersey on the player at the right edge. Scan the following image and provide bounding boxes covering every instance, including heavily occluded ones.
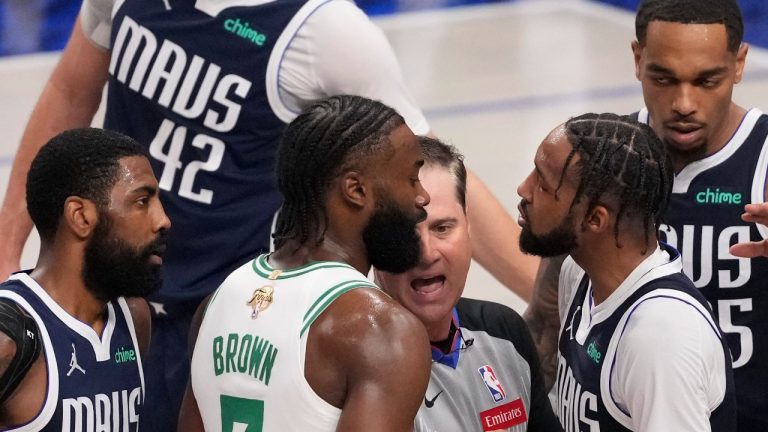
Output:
[639,109,768,432]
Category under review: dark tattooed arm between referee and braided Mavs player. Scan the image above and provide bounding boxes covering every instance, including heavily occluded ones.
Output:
[523,255,567,390]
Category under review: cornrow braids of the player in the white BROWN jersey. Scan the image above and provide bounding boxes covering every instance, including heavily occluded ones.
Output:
[272,95,405,249]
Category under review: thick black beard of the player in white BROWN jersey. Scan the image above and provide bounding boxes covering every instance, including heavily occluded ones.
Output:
[363,199,427,274]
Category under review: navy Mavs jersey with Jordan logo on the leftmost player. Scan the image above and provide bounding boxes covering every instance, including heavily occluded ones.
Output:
[0,273,144,432]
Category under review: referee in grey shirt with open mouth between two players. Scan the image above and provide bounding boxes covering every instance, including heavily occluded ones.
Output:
[375,137,560,432]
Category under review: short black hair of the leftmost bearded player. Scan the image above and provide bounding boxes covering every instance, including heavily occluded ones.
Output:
[27,128,147,240]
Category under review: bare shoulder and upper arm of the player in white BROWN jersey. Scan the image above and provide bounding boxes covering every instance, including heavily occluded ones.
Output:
[305,289,431,432]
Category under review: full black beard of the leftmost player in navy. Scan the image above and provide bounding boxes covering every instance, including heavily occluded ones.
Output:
[83,214,167,302]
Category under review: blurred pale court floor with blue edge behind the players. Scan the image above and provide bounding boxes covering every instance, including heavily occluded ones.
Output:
[0,0,768,311]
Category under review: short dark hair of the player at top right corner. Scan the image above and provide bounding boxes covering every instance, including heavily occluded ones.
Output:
[635,0,744,53]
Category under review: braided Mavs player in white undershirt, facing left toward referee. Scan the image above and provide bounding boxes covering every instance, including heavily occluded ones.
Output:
[518,114,736,432]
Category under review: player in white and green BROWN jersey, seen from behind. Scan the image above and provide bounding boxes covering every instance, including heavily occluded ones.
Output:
[179,96,429,432]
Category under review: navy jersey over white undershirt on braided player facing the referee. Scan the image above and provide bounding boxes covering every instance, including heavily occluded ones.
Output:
[557,245,736,432]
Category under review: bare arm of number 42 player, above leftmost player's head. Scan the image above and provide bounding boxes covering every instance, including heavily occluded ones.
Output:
[0,19,109,280]
